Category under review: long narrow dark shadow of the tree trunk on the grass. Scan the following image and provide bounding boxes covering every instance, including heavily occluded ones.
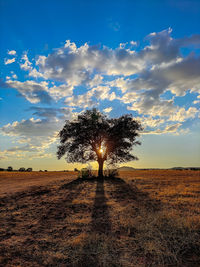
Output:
[91,178,111,234]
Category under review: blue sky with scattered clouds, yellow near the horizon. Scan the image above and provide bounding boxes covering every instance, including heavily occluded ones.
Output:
[0,0,200,170]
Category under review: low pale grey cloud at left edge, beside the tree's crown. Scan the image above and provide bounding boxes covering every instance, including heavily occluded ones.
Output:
[0,107,76,156]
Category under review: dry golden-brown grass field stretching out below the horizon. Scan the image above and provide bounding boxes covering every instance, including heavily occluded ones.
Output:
[0,170,200,267]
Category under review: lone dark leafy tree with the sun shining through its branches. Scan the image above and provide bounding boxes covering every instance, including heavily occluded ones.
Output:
[57,109,142,177]
